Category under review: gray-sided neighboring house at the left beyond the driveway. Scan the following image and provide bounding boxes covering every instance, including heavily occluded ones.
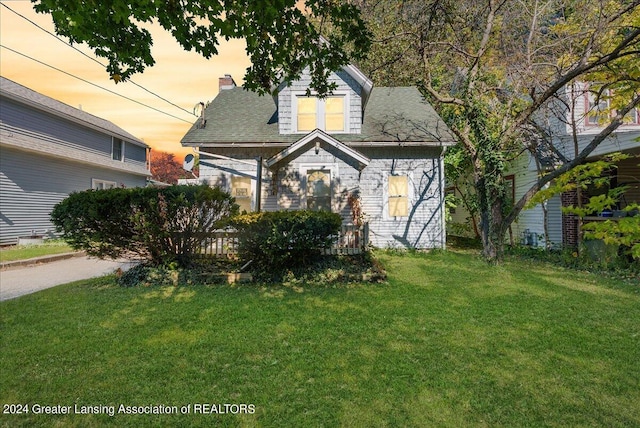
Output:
[0,77,151,245]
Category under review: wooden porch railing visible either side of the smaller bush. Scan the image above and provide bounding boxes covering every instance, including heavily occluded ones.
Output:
[202,223,369,257]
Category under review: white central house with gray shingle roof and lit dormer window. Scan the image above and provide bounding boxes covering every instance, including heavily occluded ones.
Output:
[182,66,454,248]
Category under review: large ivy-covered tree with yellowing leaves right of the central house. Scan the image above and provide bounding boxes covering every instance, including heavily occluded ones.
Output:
[355,0,640,260]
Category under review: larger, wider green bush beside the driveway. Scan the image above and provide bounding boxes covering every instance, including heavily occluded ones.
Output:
[51,185,238,266]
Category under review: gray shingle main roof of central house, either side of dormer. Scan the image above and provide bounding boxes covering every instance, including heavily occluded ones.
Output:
[181,87,455,146]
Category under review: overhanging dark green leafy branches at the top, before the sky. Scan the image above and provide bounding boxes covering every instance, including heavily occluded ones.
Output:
[32,0,370,94]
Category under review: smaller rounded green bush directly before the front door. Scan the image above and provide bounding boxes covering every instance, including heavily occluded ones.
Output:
[231,210,342,269]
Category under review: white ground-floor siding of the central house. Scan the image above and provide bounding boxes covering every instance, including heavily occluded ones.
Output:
[200,147,445,248]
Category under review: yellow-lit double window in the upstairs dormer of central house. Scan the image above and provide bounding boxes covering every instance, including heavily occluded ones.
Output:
[295,95,347,132]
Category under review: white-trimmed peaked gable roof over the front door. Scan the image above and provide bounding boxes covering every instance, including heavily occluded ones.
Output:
[267,129,371,170]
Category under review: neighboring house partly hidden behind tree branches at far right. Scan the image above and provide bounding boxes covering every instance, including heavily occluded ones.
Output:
[451,82,640,247]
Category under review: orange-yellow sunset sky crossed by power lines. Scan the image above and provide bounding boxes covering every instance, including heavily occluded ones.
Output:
[0,0,249,158]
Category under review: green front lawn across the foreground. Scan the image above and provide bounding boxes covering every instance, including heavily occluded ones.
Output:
[0,252,640,427]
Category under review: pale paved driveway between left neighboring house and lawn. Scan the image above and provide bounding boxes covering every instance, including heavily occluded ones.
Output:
[0,256,132,301]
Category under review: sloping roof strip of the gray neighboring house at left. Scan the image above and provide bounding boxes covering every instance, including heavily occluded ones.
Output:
[0,76,147,147]
